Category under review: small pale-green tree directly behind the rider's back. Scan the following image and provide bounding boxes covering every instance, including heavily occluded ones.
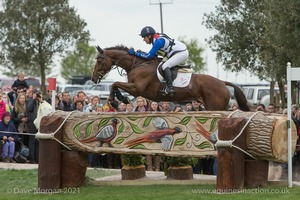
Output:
[178,37,205,72]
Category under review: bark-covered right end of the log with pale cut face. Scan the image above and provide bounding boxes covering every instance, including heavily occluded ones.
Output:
[232,112,297,163]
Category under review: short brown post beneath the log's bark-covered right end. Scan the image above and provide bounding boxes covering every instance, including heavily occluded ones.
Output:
[244,160,269,188]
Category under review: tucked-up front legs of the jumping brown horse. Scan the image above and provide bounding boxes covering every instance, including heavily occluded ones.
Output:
[110,82,136,104]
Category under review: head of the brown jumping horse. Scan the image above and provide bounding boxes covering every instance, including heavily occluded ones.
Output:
[92,46,112,83]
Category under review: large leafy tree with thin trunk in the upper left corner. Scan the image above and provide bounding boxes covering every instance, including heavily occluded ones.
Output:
[0,0,89,92]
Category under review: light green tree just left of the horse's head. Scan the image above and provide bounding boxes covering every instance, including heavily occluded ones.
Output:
[61,43,96,79]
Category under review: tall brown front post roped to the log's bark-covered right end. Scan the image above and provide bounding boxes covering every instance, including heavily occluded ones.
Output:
[217,118,246,192]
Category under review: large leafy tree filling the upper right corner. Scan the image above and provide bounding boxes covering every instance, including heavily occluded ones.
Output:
[204,0,300,106]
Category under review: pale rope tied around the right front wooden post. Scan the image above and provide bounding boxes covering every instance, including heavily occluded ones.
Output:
[215,110,259,160]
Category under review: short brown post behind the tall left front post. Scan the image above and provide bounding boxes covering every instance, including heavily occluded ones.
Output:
[61,151,88,188]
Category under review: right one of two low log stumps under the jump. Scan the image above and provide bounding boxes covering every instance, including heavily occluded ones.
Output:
[167,166,193,180]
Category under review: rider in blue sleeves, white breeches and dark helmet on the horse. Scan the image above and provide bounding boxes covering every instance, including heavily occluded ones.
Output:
[128,26,189,96]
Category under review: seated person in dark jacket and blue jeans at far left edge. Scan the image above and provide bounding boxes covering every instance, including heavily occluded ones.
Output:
[0,112,18,163]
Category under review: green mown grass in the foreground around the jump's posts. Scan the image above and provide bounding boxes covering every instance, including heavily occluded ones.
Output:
[0,169,300,200]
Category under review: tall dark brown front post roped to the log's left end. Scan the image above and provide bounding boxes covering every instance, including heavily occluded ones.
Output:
[38,116,63,189]
